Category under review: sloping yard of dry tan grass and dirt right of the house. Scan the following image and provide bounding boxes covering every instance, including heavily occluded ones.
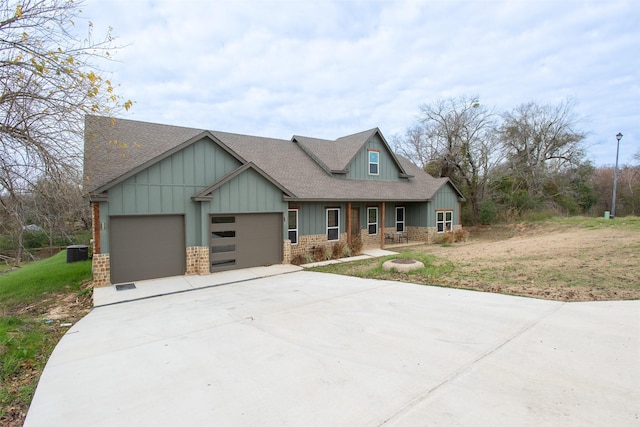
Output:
[416,223,640,301]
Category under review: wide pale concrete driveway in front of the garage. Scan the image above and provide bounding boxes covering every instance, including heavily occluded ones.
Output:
[25,271,640,427]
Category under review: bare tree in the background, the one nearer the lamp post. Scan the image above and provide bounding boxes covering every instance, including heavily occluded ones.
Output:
[500,100,585,197]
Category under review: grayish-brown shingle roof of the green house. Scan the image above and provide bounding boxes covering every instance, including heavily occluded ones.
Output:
[84,116,462,202]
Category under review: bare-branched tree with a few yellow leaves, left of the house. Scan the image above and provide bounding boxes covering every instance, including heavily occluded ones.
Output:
[0,0,131,262]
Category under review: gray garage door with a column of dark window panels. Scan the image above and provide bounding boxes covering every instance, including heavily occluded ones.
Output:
[209,213,282,272]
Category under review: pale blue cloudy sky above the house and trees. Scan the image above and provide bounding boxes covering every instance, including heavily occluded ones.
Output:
[82,0,640,165]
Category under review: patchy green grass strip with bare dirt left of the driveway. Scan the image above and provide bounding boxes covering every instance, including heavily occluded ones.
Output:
[0,252,91,425]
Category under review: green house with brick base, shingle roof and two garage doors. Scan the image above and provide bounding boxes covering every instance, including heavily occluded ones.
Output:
[84,116,463,286]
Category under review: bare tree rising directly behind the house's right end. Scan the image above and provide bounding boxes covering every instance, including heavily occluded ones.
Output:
[395,97,501,222]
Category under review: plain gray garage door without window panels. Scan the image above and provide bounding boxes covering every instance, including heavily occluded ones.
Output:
[109,215,186,283]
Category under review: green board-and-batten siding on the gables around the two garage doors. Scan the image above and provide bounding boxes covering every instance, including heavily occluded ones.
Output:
[100,139,287,252]
